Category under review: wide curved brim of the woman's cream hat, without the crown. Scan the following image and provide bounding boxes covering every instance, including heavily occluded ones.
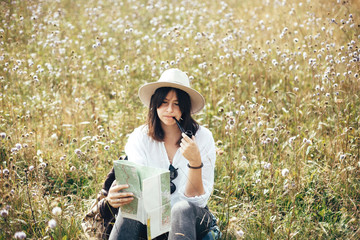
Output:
[139,82,205,114]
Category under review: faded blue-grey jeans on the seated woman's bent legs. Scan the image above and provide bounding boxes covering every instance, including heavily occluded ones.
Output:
[109,201,212,240]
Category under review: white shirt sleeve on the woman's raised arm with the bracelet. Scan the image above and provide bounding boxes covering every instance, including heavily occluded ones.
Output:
[179,128,216,207]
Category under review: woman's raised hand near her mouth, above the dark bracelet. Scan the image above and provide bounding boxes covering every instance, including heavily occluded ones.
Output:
[180,133,201,167]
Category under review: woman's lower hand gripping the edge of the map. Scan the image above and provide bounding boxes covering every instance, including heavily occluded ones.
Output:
[106,181,134,208]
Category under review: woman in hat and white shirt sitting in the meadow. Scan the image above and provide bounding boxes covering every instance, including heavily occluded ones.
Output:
[106,69,216,240]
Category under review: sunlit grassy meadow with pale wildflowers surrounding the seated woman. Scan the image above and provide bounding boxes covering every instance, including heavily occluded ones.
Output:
[0,0,360,240]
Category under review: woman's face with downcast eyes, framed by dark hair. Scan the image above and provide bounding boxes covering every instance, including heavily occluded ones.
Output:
[157,90,182,126]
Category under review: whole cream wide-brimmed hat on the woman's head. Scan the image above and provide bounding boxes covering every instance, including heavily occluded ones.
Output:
[139,68,205,113]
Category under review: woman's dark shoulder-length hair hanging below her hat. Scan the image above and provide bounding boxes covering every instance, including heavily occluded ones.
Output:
[147,87,199,144]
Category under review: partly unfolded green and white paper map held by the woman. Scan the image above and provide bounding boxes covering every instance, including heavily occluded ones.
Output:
[114,160,171,239]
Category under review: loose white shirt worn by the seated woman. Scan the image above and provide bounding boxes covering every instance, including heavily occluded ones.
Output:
[125,125,216,207]
